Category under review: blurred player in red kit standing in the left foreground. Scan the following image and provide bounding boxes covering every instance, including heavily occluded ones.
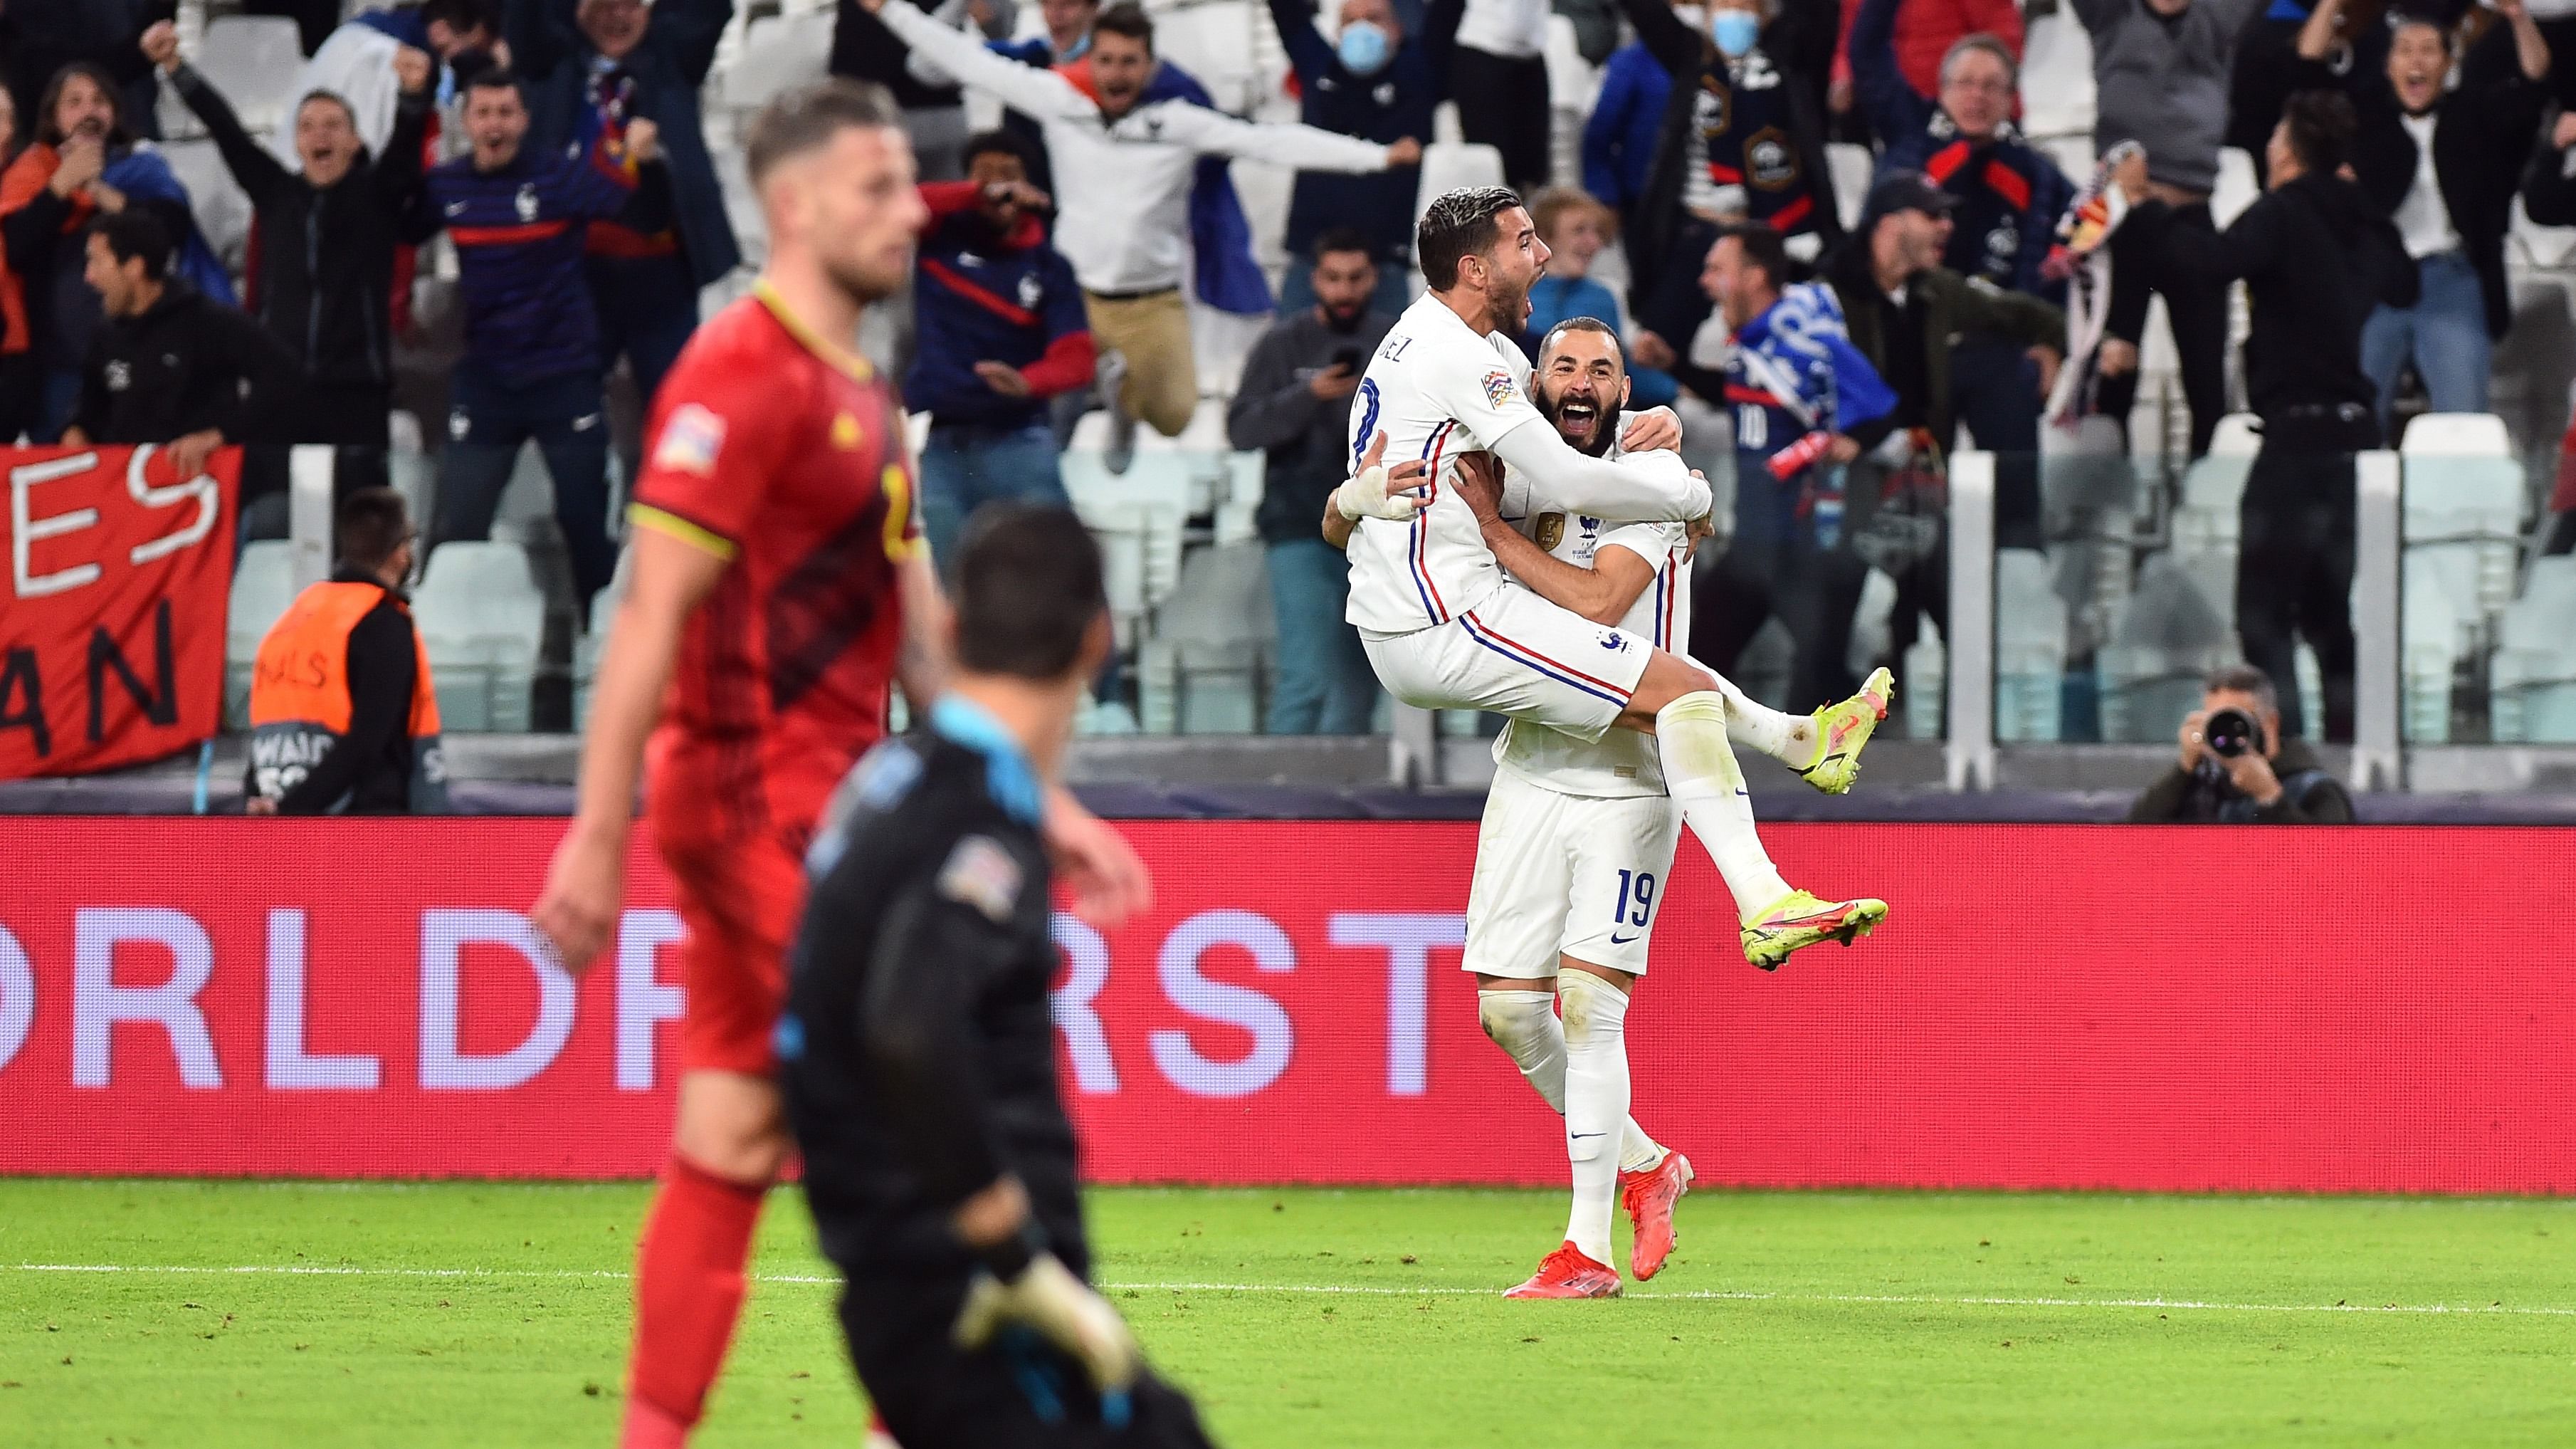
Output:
[536,83,1146,1449]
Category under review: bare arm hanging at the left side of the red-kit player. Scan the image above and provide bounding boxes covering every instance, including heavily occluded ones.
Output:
[533,528,732,969]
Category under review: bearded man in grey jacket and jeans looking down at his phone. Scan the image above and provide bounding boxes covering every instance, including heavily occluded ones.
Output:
[1226,227,1396,735]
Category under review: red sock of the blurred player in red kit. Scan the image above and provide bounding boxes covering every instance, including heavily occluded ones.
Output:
[626,1153,767,1449]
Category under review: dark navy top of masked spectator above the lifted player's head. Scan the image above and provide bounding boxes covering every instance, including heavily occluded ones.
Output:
[1270,0,1466,266]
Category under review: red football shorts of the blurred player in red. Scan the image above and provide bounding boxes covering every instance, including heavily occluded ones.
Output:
[654,815,804,1078]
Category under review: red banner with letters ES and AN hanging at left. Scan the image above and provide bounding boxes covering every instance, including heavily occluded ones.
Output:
[0,446,242,779]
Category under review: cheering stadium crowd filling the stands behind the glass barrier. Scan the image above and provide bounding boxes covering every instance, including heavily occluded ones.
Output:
[0,0,2576,735]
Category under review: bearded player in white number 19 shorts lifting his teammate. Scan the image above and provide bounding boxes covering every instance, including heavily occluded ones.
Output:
[1324,317,1888,1297]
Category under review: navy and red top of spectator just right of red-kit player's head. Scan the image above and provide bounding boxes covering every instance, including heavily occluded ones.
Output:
[904,183,1092,428]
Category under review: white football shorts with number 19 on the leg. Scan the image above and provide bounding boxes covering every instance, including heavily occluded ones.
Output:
[1461,771,1682,980]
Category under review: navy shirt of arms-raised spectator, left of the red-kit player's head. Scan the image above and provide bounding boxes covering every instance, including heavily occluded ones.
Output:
[402,136,636,382]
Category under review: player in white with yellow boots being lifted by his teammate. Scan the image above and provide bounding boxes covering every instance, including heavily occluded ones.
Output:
[1335,188,1888,969]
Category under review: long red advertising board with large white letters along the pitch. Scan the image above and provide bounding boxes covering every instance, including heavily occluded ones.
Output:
[0,820,2576,1194]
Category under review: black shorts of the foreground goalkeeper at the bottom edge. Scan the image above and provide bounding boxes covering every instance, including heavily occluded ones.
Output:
[840,1252,1211,1449]
